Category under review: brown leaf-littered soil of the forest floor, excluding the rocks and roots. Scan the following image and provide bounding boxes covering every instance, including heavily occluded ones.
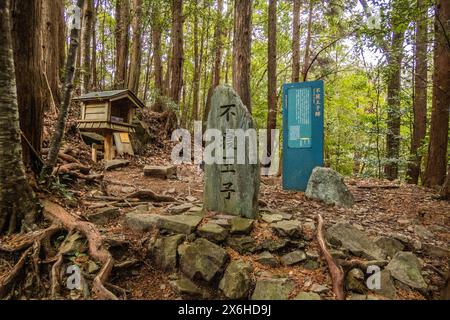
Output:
[0,115,450,300]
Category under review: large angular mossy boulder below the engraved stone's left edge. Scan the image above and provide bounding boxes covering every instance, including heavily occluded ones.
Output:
[180,238,229,282]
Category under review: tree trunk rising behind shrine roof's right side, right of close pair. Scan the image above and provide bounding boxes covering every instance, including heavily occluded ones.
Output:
[128,0,142,94]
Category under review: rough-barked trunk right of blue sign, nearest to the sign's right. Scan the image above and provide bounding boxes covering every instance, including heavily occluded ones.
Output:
[384,31,405,181]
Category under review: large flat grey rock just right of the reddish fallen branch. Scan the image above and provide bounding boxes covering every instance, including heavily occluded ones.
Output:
[327,223,386,260]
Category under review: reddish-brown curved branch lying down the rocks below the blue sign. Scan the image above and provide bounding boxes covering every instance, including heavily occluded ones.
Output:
[317,214,345,300]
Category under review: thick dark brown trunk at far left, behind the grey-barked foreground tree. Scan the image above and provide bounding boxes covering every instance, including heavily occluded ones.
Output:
[11,0,44,172]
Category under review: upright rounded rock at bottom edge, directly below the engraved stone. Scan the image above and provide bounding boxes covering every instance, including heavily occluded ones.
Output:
[219,260,253,300]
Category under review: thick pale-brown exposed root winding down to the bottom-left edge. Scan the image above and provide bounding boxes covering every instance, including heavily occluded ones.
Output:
[42,200,117,300]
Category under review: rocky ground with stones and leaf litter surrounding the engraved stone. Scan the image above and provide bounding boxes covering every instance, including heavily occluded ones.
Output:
[48,154,450,300]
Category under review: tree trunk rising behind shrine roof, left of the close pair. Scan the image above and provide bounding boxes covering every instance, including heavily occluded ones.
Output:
[114,0,130,89]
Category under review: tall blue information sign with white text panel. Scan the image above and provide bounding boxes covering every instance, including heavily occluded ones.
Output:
[283,81,324,191]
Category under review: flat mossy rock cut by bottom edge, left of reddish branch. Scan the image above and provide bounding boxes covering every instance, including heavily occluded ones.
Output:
[251,278,295,300]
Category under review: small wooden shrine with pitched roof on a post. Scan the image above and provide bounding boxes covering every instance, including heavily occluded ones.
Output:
[74,90,144,161]
